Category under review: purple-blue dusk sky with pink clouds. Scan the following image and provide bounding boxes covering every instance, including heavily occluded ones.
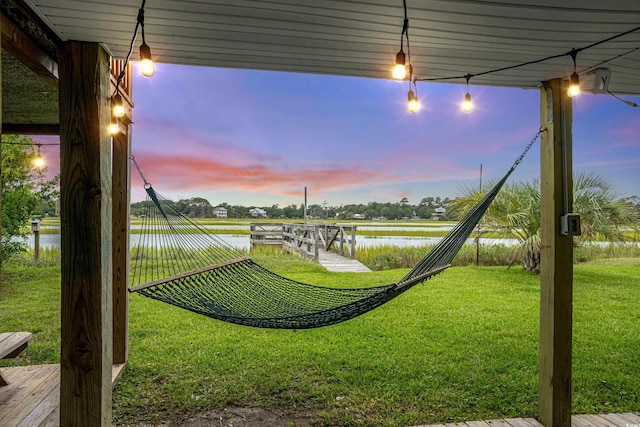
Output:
[39,64,640,206]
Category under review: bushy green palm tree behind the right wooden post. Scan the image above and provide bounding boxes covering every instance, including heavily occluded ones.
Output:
[452,172,640,274]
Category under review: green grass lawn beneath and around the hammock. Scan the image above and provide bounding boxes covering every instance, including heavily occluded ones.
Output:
[0,254,640,426]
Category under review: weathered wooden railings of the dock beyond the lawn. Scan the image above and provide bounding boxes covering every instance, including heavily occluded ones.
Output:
[250,222,357,259]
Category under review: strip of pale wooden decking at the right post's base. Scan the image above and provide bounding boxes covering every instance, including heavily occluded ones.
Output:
[414,412,640,427]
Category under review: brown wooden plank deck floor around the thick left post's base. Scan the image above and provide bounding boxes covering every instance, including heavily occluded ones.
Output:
[0,364,124,427]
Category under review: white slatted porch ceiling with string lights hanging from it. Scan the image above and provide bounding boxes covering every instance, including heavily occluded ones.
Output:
[20,0,640,94]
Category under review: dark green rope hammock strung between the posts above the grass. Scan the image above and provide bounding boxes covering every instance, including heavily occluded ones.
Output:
[129,132,540,329]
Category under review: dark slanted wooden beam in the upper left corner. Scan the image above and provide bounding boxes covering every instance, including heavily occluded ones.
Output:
[1,15,58,86]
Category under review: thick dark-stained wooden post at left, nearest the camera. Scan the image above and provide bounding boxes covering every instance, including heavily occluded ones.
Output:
[58,41,113,426]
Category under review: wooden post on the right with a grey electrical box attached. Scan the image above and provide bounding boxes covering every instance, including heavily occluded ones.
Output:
[538,79,573,427]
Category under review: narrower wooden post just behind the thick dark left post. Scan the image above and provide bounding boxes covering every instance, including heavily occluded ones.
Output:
[112,120,131,364]
